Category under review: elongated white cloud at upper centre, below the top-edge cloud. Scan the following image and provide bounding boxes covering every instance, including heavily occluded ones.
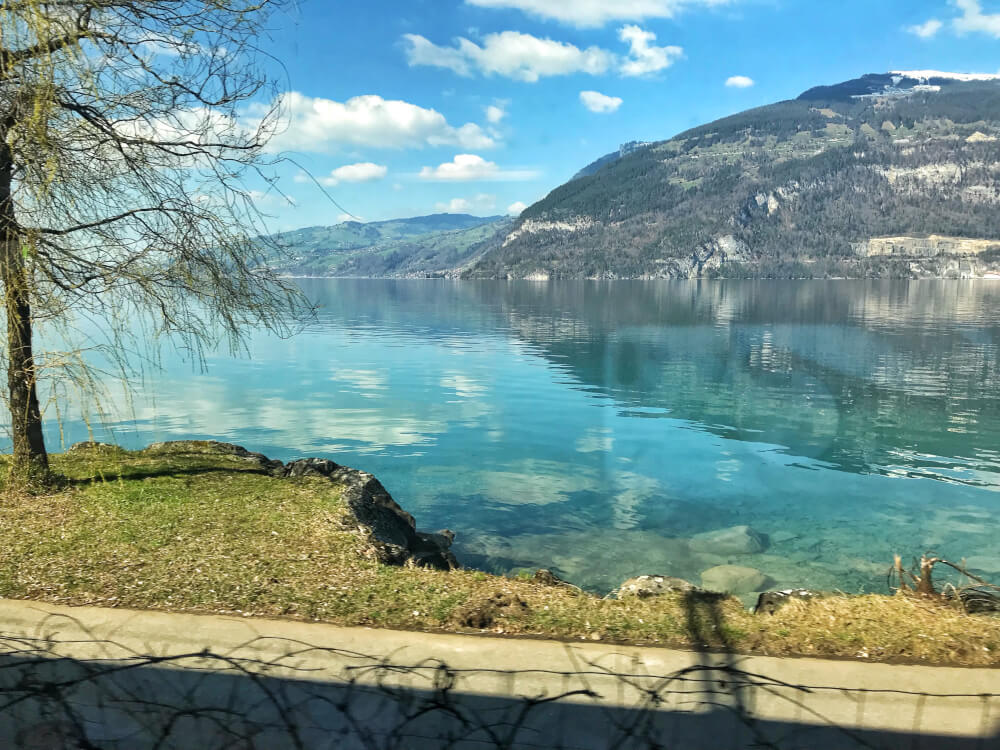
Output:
[403,31,615,83]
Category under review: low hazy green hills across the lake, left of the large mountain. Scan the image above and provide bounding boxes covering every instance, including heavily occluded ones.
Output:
[268,214,512,276]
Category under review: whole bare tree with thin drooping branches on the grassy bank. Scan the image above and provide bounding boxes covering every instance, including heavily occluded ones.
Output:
[0,0,304,481]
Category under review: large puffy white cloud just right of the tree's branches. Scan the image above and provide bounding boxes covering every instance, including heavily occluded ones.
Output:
[268,91,496,153]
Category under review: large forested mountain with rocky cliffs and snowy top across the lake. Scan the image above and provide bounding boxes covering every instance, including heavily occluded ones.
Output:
[464,71,1000,278]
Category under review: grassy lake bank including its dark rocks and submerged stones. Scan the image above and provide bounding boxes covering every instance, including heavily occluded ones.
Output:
[7,441,1000,666]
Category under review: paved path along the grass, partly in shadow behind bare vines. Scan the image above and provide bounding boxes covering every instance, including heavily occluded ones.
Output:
[0,600,1000,750]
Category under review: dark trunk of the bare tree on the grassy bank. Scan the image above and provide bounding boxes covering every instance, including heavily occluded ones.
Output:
[0,132,49,481]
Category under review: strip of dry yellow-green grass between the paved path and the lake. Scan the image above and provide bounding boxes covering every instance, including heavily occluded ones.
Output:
[0,450,1000,665]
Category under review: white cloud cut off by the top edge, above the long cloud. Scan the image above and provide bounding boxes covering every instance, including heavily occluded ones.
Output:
[465,0,729,27]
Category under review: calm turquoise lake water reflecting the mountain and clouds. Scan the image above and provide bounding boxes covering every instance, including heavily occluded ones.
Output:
[31,279,1000,592]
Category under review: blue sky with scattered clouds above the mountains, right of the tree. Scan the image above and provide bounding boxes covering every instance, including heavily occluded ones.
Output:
[253,0,1000,230]
